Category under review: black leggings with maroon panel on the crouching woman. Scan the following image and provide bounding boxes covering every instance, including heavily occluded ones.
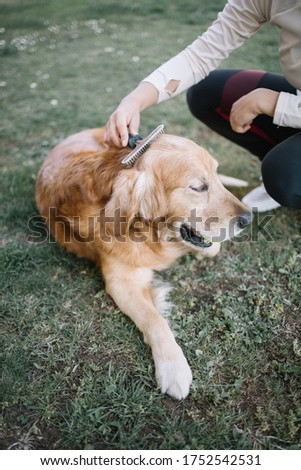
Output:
[187,69,301,209]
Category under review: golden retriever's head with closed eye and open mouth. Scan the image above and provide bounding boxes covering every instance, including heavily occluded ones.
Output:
[106,134,252,249]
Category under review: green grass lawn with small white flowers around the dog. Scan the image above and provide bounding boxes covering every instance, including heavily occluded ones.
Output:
[0,0,301,449]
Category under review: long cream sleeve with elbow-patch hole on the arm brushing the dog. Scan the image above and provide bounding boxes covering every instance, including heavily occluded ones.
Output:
[143,0,266,103]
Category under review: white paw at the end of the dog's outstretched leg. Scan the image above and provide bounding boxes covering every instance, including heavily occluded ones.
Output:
[155,348,192,400]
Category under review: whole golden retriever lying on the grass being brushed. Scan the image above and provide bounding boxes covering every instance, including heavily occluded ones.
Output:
[36,129,251,400]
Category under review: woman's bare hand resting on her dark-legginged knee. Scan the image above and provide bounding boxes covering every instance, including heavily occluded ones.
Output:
[230,88,279,133]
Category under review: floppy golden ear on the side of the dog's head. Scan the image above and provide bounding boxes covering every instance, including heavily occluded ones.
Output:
[100,168,166,238]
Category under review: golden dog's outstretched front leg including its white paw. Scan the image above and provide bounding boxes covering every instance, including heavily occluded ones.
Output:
[102,260,192,400]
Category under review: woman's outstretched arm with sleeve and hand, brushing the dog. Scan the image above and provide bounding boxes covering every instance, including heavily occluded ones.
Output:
[105,0,264,147]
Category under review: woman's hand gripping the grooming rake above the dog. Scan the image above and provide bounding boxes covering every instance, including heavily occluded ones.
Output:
[104,82,158,148]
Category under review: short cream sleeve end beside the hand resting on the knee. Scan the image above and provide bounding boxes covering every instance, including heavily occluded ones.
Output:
[273,92,301,129]
